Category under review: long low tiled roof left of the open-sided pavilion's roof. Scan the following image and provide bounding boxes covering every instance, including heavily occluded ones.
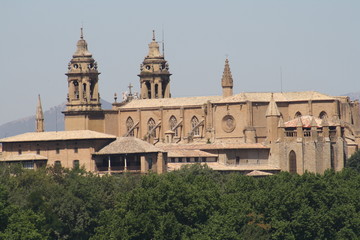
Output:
[0,130,116,143]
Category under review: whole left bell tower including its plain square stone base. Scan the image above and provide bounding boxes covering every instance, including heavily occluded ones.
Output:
[63,28,104,132]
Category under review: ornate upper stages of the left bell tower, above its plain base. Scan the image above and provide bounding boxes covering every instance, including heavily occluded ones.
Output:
[66,28,101,111]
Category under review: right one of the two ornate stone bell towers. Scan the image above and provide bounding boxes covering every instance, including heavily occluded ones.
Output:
[138,31,171,99]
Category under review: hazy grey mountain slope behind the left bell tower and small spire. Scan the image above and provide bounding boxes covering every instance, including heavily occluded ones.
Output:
[0,99,112,138]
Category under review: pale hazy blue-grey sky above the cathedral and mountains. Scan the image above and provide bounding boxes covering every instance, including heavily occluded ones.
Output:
[0,0,360,124]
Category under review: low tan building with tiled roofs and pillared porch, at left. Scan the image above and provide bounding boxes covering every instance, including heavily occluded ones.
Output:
[0,130,167,174]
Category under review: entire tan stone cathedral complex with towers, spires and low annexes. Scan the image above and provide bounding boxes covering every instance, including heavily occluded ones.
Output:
[0,31,360,175]
